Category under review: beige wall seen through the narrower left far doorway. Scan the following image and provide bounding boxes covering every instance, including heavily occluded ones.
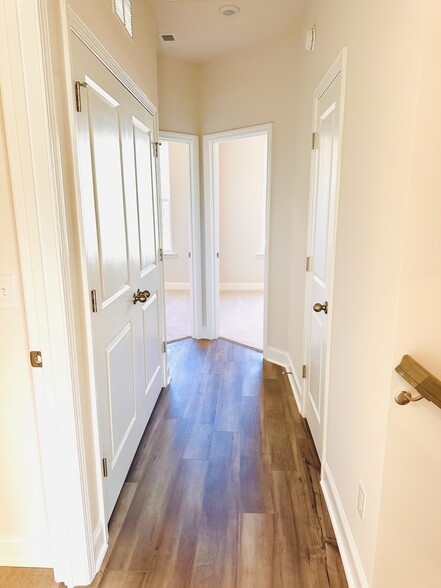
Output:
[164,141,190,284]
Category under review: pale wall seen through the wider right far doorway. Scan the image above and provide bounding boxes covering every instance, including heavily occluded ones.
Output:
[219,136,266,289]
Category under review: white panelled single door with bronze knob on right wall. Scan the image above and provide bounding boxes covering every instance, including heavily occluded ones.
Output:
[305,63,342,459]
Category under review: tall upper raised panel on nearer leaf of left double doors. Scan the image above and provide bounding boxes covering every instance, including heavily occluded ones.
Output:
[88,80,130,307]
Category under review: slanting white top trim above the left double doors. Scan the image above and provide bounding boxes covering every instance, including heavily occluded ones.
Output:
[67,6,157,115]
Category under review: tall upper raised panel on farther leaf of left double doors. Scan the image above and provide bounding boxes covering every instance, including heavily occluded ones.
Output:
[133,117,156,275]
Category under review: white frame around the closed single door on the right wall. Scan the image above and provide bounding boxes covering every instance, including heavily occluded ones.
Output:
[301,47,347,468]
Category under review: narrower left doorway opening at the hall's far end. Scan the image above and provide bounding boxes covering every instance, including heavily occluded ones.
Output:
[159,132,201,342]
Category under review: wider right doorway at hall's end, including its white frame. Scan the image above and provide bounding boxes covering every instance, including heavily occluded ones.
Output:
[204,125,272,352]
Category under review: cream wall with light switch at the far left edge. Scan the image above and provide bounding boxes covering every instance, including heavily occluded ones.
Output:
[0,101,50,565]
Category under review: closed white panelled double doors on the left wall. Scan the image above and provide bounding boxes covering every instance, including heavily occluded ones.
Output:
[72,36,163,518]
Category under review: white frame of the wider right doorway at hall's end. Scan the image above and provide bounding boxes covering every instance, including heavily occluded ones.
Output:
[203,123,273,357]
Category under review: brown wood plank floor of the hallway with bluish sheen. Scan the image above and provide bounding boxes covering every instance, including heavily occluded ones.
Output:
[0,339,347,588]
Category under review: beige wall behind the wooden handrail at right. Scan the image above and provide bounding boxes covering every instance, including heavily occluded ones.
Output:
[373,0,441,588]
